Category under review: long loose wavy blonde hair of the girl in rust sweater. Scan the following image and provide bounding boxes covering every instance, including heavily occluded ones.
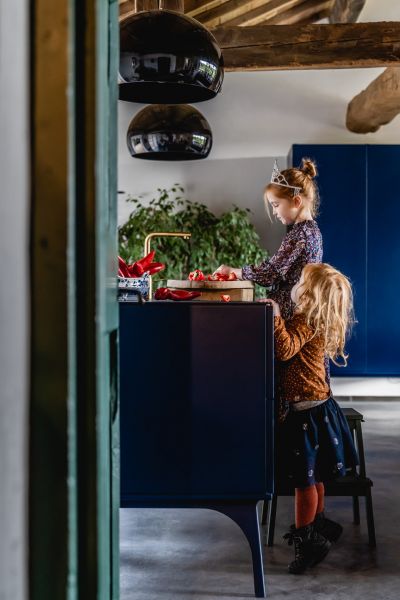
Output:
[296,263,355,367]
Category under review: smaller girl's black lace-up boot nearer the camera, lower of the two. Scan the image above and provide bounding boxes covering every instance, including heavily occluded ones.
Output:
[283,524,331,575]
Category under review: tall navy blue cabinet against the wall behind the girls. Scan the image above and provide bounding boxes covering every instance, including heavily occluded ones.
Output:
[292,144,400,376]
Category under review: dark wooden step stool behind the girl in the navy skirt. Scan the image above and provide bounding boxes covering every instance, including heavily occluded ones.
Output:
[261,408,376,547]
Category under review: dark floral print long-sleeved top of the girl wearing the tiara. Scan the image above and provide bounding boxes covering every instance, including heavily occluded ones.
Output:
[242,220,322,319]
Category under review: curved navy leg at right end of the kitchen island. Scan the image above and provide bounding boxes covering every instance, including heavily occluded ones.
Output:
[209,502,266,598]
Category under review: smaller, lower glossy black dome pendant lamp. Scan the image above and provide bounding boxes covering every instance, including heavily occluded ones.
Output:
[127,104,212,160]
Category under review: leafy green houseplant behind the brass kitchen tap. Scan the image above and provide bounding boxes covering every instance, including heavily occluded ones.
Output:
[118,184,267,287]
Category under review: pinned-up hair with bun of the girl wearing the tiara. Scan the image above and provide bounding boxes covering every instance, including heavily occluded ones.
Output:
[264,158,319,218]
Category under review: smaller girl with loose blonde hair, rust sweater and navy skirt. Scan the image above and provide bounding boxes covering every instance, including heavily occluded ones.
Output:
[267,263,358,574]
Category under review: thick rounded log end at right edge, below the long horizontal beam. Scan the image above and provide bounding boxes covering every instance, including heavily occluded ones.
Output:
[346,67,400,133]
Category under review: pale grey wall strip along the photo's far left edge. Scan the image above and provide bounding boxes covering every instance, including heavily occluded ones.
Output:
[0,0,29,600]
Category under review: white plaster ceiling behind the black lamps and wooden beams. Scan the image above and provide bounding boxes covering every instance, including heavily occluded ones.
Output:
[119,0,400,162]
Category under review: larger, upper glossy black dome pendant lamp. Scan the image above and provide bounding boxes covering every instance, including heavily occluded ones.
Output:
[119,10,224,104]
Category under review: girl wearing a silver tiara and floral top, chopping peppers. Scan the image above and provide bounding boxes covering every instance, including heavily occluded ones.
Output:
[216,158,322,319]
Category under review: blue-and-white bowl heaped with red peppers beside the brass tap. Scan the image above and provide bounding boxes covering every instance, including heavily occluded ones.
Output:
[118,250,165,302]
